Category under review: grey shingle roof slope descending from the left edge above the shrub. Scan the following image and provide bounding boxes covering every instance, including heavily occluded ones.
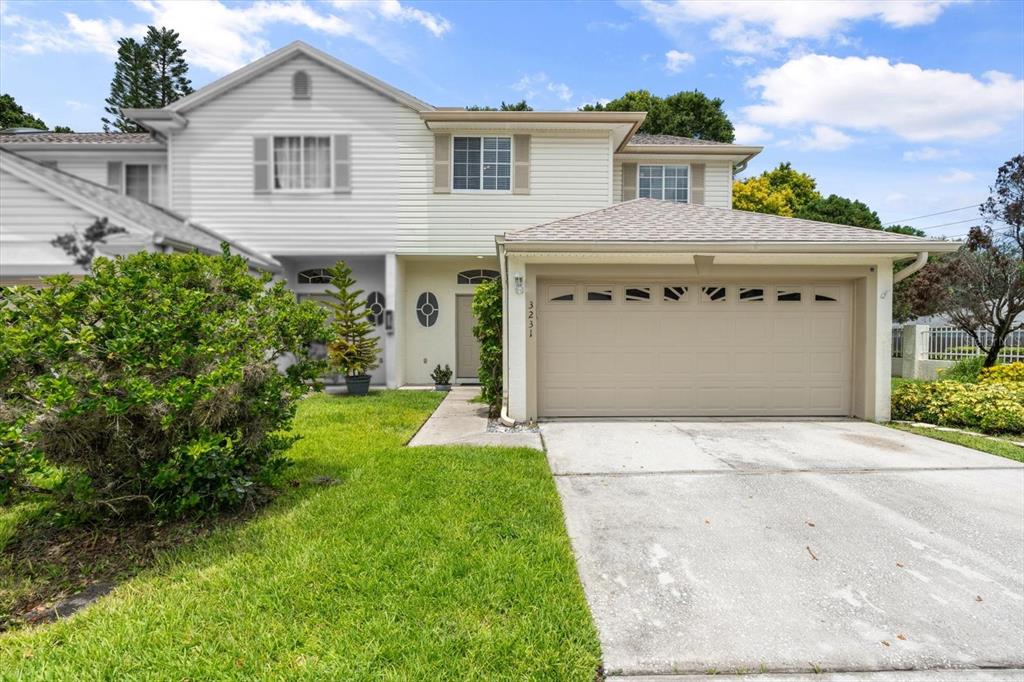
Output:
[0,148,281,270]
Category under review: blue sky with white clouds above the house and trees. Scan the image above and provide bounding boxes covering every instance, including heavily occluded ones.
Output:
[0,0,1024,236]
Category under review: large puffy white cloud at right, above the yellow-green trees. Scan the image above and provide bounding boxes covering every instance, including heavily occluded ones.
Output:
[742,54,1024,141]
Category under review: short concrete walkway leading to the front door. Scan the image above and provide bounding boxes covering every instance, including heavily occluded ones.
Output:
[409,386,544,450]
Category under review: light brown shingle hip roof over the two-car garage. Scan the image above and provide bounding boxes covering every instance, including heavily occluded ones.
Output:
[505,199,958,249]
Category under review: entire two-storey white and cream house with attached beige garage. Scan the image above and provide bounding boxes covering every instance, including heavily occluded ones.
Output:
[0,43,958,420]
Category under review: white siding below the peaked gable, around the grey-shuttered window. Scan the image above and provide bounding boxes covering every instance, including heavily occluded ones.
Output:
[171,57,423,255]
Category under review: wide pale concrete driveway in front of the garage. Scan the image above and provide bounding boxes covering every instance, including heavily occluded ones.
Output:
[542,421,1024,679]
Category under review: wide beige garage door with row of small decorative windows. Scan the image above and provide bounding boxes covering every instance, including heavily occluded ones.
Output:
[537,281,852,417]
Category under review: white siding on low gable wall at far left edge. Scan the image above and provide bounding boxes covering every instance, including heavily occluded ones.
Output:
[0,170,94,276]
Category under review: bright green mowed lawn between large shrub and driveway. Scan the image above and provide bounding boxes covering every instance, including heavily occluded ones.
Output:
[0,391,600,681]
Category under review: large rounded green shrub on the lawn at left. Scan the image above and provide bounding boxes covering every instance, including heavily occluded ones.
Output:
[0,252,325,517]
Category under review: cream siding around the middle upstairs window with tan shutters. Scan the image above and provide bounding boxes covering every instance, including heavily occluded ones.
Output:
[425,130,611,255]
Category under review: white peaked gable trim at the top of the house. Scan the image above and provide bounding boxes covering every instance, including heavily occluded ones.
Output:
[164,40,434,114]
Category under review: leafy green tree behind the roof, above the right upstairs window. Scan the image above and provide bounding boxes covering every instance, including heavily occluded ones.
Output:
[581,90,735,142]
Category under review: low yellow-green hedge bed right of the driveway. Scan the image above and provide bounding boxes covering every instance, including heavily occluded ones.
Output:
[892,378,1024,433]
